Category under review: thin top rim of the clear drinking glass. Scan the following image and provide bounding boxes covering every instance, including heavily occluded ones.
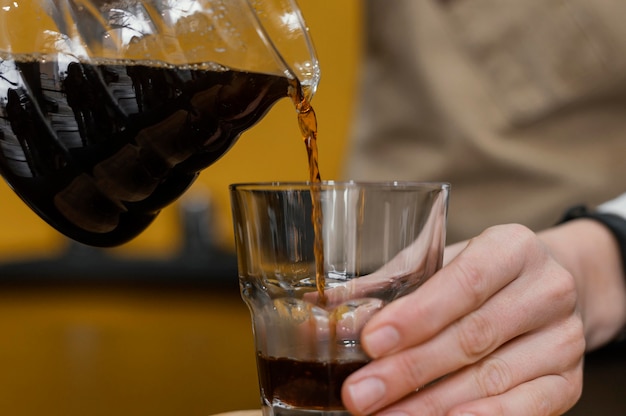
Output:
[228,180,451,191]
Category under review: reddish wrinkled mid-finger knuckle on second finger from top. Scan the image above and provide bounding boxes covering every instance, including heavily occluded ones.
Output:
[457,312,496,362]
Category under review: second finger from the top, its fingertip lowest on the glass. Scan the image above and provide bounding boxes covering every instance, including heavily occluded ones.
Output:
[347,266,584,412]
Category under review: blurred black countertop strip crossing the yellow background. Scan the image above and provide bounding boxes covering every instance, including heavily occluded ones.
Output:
[0,199,239,289]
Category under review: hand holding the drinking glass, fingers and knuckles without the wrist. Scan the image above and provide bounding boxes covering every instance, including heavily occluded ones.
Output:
[342,225,585,416]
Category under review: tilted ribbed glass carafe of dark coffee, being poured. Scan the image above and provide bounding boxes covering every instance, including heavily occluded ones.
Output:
[0,0,319,246]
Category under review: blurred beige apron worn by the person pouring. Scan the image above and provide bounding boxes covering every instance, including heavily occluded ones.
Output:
[345,0,626,242]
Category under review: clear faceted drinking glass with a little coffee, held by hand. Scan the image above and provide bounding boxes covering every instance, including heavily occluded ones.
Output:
[230,182,449,416]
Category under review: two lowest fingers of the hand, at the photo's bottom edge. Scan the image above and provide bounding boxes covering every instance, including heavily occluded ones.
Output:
[344,317,584,416]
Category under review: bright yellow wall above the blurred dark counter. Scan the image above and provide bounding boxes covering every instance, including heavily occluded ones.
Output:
[0,0,361,261]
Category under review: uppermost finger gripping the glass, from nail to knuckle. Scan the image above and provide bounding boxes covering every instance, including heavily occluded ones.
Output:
[362,226,545,358]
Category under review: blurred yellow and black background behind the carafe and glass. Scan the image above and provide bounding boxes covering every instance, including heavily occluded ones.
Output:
[0,0,361,416]
